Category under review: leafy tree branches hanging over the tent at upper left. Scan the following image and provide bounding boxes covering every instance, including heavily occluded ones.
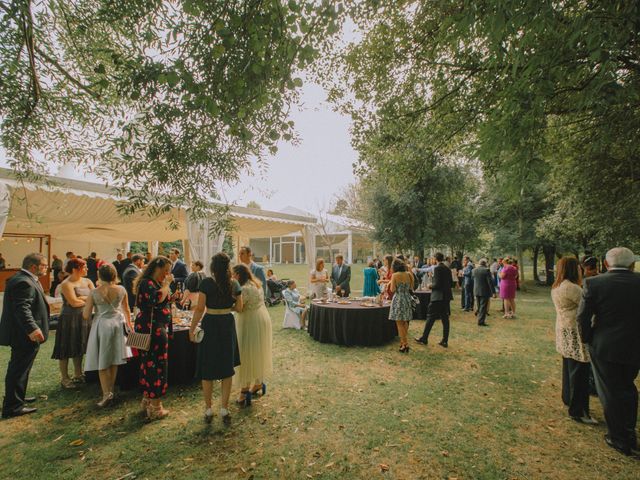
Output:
[0,0,342,222]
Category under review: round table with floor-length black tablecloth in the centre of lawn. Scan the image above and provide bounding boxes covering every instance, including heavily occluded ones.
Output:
[308,301,398,346]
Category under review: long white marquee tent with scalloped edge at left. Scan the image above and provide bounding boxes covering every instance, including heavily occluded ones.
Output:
[0,168,316,274]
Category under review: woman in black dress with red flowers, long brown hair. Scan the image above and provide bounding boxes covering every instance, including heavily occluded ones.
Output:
[134,256,173,420]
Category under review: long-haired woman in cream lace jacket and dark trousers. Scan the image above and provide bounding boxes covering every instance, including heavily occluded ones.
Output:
[551,257,597,424]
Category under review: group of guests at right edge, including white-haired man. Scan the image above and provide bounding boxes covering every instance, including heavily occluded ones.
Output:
[551,247,640,455]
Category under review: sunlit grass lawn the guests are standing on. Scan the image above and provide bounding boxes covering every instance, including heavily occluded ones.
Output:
[0,265,640,480]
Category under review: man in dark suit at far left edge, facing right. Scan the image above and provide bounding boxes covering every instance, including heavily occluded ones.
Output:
[0,253,49,418]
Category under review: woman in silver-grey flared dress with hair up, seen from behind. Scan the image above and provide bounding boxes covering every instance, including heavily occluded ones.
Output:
[82,263,133,407]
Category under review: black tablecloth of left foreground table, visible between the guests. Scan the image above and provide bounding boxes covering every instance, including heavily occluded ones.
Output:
[86,327,197,390]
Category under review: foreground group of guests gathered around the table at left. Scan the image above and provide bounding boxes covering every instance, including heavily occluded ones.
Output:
[0,247,272,425]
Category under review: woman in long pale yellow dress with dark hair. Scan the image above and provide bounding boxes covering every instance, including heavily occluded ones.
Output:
[233,264,273,406]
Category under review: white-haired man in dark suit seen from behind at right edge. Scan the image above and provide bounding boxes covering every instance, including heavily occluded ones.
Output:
[578,247,640,455]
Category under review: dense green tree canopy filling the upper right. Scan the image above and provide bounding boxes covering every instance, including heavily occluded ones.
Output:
[331,0,640,256]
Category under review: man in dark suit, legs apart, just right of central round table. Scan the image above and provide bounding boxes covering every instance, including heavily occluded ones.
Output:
[415,252,453,348]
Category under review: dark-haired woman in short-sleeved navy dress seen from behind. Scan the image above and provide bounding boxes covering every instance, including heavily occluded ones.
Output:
[189,253,242,425]
